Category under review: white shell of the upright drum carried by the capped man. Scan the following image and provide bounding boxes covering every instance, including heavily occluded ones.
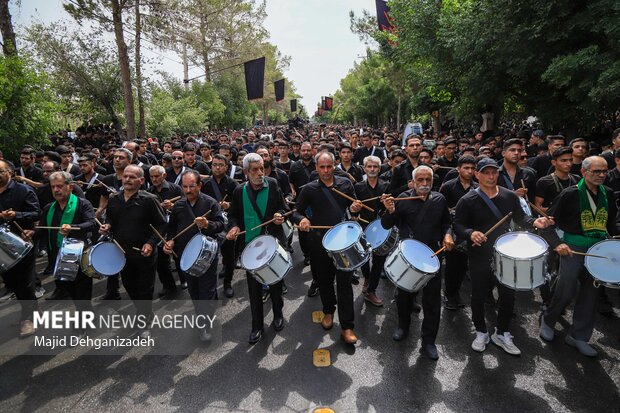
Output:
[493,232,548,291]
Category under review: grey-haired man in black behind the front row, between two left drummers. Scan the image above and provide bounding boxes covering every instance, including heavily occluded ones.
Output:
[147,165,185,297]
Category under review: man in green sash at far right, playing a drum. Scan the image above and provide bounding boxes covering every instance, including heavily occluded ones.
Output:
[540,156,619,357]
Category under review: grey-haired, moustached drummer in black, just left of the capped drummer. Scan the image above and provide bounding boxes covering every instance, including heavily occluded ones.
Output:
[381,165,454,360]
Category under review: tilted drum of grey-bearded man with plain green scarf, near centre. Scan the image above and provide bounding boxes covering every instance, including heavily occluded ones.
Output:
[241,235,293,285]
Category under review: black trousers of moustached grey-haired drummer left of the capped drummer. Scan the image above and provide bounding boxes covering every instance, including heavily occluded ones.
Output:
[396,275,441,344]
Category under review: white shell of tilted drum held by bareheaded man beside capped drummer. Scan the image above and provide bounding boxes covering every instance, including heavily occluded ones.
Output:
[383,240,439,293]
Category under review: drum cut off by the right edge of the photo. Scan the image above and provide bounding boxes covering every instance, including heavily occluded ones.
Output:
[584,239,620,288]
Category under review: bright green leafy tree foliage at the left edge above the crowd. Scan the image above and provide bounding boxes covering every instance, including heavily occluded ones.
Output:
[0,55,59,159]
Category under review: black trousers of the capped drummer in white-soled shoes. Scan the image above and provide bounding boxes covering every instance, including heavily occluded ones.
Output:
[468,251,515,334]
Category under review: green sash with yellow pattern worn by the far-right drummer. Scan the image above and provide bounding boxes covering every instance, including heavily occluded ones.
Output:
[562,178,609,248]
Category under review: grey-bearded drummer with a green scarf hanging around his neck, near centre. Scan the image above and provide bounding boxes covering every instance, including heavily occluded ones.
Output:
[226,153,288,344]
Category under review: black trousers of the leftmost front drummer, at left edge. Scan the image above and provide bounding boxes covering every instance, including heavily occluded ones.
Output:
[2,248,37,321]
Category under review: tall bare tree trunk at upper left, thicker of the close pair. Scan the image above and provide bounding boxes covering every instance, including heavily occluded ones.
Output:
[110,0,136,140]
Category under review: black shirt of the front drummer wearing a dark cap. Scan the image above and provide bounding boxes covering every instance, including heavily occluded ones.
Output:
[454,186,534,257]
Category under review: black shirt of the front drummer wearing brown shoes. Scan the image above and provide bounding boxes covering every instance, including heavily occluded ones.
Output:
[293,176,358,225]
